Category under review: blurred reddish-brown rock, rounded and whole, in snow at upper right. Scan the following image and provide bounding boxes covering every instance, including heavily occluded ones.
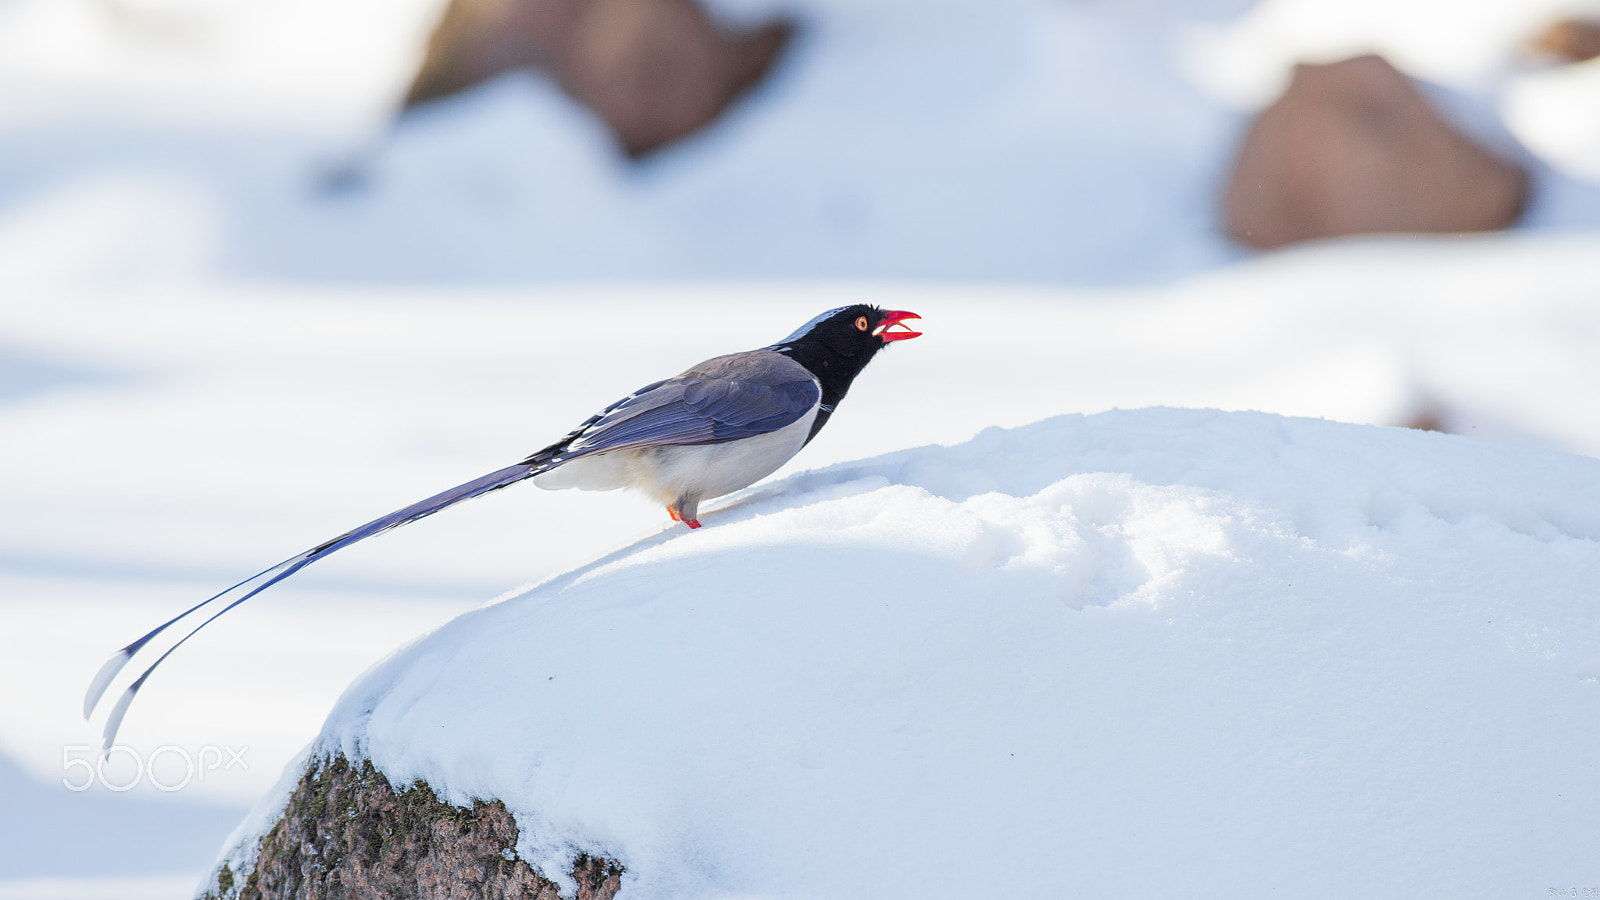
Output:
[1222,56,1528,250]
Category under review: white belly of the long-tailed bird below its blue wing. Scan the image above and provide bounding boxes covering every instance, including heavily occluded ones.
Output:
[533,408,816,504]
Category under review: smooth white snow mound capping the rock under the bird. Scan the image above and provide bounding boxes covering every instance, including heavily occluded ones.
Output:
[291,410,1600,897]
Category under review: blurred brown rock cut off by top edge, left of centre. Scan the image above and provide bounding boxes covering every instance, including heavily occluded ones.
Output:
[405,0,794,157]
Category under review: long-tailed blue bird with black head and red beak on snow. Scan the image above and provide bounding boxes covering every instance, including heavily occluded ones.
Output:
[83,304,922,751]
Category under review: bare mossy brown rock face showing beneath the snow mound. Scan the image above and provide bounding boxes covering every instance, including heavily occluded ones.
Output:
[202,756,622,900]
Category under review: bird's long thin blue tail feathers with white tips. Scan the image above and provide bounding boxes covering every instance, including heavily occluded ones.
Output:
[83,464,537,748]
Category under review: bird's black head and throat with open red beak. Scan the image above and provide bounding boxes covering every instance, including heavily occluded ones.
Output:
[766,303,922,436]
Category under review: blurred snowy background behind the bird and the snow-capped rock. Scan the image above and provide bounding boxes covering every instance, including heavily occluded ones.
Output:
[0,0,1600,898]
